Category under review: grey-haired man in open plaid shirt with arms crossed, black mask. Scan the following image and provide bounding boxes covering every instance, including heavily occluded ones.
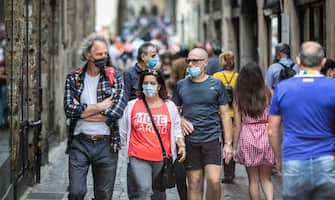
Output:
[64,33,126,200]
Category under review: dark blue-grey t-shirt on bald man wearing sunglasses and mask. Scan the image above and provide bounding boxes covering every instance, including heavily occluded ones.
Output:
[172,76,229,143]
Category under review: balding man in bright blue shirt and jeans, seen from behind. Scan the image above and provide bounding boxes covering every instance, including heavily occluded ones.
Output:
[269,42,335,200]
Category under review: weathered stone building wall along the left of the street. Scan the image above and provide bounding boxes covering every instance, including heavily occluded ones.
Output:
[0,0,95,199]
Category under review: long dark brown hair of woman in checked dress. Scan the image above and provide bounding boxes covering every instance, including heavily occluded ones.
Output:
[234,62,271,118]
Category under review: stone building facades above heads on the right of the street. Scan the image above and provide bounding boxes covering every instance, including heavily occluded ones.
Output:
[176,0,335,71]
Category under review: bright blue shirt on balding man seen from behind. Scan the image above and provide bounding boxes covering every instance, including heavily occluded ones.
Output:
[270,72,335,161]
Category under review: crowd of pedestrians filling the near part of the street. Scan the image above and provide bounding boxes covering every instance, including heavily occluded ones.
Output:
[64,28,335,200]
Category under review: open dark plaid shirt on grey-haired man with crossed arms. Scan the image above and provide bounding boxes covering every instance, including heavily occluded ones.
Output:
[64,65,127,144]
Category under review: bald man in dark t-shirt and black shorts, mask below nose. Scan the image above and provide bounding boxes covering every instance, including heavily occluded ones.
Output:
[172,48,233,200]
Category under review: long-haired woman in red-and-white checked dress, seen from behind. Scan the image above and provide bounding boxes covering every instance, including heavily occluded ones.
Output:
[233,63,274,200]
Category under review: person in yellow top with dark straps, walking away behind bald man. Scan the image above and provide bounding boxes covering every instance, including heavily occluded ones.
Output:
[214,51,238,184]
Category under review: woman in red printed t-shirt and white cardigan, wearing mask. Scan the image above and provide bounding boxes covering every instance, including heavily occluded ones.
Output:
[120,70,186,200]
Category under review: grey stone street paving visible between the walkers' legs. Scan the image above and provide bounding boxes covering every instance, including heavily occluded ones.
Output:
[21,142,281,200]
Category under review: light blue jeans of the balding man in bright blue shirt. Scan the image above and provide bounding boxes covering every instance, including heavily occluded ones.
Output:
[282,156,335,200]
